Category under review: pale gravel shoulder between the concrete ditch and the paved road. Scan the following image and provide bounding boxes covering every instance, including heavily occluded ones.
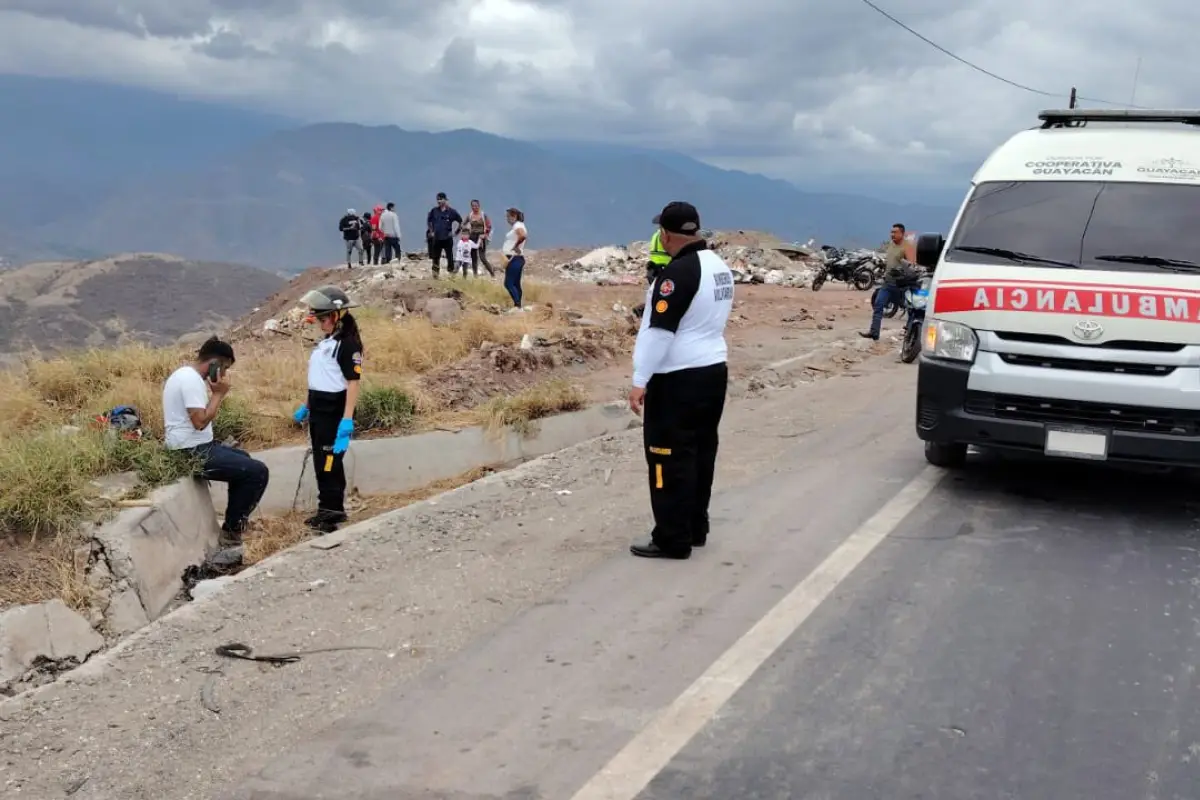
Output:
[0,321,905,800]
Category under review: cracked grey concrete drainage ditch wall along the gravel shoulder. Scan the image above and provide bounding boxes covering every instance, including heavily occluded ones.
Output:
[0,403,640,696]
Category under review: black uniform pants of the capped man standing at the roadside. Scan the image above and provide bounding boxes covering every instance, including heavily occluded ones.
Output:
[642,363,730,551]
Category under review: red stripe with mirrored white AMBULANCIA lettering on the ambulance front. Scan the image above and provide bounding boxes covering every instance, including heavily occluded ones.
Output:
[934,283,1200,321]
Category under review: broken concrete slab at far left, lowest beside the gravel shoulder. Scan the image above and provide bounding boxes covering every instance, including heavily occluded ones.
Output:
[0,600,104,688]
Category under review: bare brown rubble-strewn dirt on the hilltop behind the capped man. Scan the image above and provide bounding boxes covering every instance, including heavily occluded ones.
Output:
[226,230,870,408]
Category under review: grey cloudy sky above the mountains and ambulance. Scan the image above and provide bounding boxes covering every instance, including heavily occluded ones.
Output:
[0,0,1200,182]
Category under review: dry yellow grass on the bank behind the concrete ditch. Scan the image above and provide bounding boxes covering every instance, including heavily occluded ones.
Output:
[0,279,609,539]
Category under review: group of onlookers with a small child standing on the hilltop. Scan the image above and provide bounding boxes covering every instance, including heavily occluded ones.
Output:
[337,192,528,308]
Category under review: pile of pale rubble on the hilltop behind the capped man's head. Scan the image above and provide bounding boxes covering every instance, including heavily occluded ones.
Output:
[558,233,821,288]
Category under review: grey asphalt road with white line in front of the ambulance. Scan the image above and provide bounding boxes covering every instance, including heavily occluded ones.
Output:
[224,383,1200,800]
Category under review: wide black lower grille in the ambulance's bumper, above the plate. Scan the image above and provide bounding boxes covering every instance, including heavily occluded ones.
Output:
[964,392,1200,437]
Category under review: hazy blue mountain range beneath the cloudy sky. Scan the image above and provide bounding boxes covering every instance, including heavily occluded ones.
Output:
[0,76,954,272]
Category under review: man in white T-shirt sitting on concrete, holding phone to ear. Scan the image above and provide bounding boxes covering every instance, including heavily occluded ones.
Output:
[162,336,270,548]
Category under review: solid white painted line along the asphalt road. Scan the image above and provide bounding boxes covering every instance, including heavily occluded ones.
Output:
[572,467,942,800]
